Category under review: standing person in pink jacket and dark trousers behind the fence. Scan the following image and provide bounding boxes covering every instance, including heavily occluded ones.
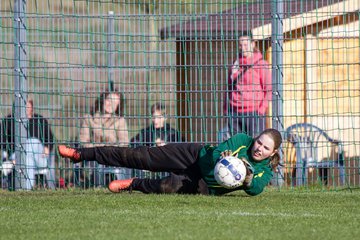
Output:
[224,32,272,137]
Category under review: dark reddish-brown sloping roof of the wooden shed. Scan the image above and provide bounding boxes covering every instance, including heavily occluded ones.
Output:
[160,0,342,39]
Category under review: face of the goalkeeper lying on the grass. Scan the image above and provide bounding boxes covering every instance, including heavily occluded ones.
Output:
[251,134,277,161]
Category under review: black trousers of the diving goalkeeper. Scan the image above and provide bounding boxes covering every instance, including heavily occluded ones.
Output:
[79,143,208,194]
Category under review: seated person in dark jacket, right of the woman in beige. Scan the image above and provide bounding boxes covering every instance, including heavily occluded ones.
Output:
[130,103,181,147]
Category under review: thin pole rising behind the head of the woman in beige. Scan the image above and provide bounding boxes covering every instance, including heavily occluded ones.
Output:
[107,11,115,91]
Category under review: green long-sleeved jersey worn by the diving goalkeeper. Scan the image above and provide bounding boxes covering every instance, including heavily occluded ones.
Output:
[198,133,273,196]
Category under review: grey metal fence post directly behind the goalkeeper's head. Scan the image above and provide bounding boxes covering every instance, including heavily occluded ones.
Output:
[271,0,284,186]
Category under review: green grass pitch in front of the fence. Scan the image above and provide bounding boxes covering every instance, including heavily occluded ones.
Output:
[0,189,360,240]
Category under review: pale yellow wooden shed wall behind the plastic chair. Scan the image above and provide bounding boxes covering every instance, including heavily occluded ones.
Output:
[268,36,360,156]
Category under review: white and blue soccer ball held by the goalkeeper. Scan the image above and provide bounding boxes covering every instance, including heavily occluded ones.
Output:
[214,156,246,189]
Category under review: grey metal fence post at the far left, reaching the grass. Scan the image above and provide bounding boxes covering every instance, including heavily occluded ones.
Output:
[13,0,27,189]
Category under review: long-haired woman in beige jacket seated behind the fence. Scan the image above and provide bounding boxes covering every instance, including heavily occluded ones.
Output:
[79,89,129,186]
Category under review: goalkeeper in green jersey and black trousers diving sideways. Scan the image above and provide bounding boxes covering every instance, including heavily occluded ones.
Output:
[58,129,282,196]
